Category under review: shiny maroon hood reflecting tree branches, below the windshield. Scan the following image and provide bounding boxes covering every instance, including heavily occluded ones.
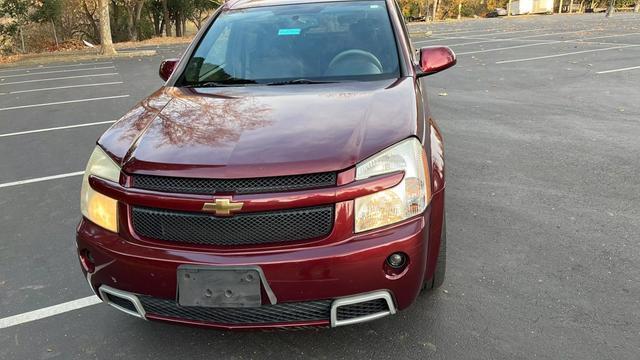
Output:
[99,78,418,178]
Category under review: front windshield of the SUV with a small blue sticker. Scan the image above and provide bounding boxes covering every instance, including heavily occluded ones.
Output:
[179,1,400,86]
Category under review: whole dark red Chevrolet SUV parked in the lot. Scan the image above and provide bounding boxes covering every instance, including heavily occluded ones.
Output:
[77,0,456,329]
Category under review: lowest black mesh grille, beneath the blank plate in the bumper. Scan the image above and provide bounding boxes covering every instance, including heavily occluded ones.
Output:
[139,296,331,324]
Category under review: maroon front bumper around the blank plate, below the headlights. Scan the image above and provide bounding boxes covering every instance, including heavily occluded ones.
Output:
[76,209,430,329]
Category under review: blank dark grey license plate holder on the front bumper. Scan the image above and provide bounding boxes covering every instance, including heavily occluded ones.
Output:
[178,266,262,307]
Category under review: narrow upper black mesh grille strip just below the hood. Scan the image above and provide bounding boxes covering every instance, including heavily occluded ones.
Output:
[133,172,336,194]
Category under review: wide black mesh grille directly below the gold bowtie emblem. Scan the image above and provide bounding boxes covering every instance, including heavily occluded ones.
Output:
[132,205,334,246]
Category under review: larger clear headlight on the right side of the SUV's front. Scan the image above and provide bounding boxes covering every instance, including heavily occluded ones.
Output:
[355,138,431,232]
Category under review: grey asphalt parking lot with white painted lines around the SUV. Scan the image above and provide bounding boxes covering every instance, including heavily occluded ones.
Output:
[0,13,640,359]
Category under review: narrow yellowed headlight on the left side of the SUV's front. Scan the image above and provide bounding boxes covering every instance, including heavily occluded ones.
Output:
[80,146,120,232]
